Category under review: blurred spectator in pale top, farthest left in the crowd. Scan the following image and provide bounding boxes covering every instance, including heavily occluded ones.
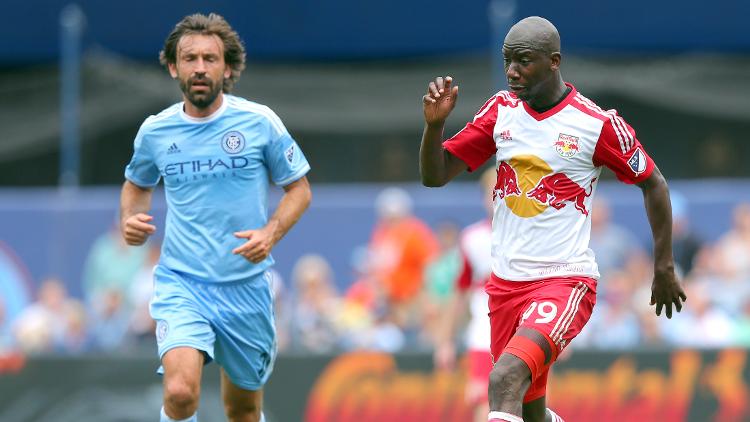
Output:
[12,277,86,354]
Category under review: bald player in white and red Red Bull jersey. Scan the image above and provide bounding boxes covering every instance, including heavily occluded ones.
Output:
[420,17,686,422]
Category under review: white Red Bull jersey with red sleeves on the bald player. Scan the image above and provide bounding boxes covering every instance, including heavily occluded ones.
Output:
[443,85,654,281]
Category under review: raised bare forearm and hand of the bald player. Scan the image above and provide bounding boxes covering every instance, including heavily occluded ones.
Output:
[419,76,466,187]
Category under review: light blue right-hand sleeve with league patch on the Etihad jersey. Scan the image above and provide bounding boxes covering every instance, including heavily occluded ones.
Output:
[263,112,310,186]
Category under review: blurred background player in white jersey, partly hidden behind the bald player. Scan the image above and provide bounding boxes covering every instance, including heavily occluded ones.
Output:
[435,168,497,422]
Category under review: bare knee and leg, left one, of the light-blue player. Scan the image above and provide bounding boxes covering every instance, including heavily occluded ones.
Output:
[162,347,204,420]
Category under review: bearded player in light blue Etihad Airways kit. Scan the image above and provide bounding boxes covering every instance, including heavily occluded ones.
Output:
[120,14,311,422]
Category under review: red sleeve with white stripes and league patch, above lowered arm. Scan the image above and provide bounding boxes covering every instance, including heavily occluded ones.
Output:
[593,116,654,184]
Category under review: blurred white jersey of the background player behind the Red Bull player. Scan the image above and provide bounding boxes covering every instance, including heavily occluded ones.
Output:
[456,220,492,350]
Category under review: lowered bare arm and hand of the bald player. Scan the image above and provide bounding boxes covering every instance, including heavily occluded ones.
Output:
[638,167,687,318]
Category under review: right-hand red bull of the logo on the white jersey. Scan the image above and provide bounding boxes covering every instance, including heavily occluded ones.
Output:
[526,173,596,215]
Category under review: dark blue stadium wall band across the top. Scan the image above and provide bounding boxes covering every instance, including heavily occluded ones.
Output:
[0,0,750,64]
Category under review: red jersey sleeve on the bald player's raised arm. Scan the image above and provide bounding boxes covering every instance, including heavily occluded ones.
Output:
[443,96,498,171]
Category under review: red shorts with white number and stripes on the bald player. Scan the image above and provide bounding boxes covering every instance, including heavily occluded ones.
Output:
[485,275,596,403]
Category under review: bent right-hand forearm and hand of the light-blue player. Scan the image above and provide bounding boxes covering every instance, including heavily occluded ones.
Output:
[232,176,312,264]
